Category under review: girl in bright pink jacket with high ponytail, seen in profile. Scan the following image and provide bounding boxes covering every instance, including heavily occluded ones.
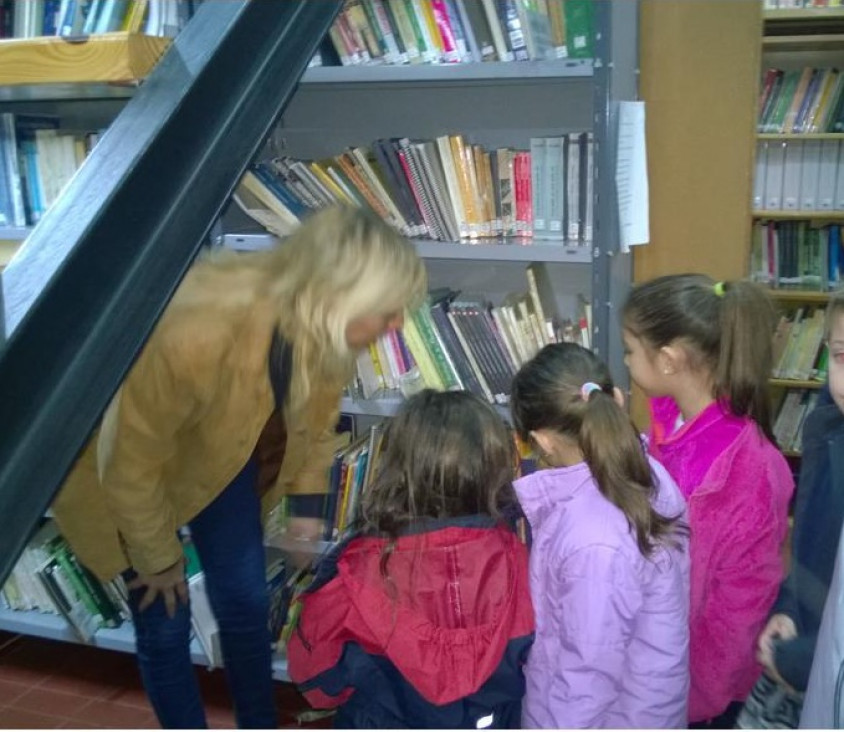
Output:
[623,274,794,728]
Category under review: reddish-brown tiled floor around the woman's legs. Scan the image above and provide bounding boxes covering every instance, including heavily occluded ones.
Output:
[0,632,324,729]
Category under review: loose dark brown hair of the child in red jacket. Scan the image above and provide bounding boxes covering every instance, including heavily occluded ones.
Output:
[361,389,517,539]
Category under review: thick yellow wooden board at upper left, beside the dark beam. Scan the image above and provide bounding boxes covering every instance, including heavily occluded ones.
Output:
[0,33,171,87]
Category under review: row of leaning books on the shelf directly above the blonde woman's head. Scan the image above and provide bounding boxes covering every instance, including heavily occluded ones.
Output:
[234,132,594,244]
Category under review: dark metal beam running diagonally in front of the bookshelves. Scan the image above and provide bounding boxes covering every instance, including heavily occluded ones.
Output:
[0,0,341,583]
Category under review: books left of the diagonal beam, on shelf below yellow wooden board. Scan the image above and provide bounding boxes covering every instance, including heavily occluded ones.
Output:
[0,112,99,227]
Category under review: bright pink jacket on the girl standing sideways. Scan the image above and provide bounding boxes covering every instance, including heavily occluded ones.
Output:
[649,397,794,722]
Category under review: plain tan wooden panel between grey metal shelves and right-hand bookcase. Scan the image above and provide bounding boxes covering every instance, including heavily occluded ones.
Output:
[632,0,762,426]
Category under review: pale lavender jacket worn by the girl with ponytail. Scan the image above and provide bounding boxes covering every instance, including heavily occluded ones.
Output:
[516,460,689,728]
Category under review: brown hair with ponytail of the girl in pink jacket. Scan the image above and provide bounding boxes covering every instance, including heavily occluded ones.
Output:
[623,274,776,444]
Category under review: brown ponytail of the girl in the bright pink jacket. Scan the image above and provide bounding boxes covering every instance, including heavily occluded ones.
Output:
[715,281,776,444]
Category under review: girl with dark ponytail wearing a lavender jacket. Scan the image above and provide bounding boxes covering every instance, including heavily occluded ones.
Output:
[512,343,689,728]
